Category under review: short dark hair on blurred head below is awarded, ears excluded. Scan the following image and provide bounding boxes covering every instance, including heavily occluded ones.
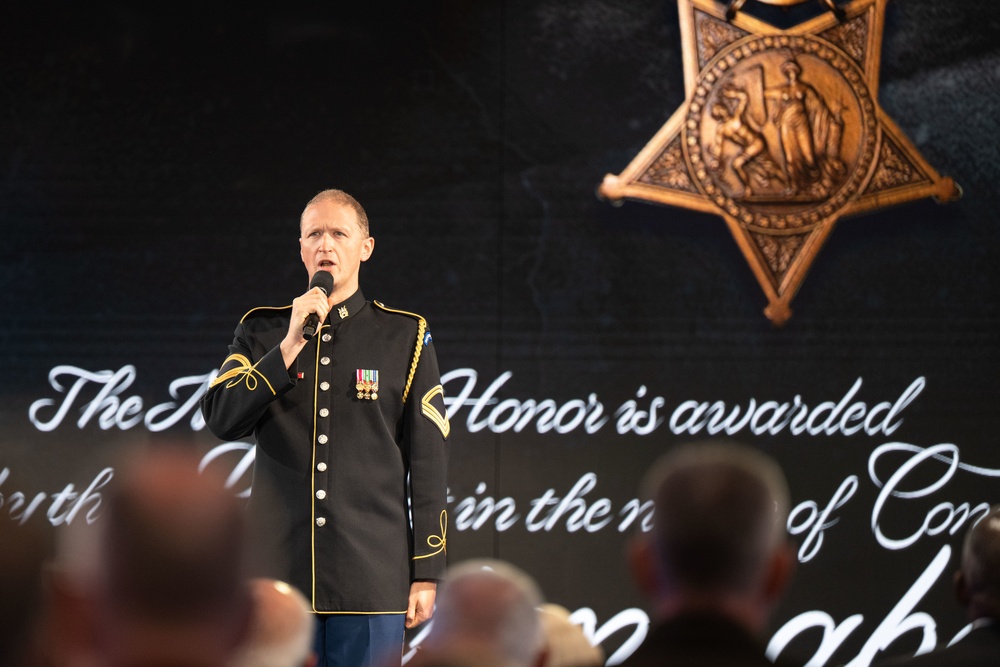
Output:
[643,441,788,592]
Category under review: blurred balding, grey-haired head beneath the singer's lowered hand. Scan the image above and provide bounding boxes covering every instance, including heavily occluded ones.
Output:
[421,560,544,667]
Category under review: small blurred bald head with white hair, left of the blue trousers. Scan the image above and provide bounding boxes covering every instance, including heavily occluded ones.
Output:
[232,579,316,667]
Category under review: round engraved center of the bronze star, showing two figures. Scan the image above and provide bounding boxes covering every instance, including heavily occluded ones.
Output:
[683,35,878,234]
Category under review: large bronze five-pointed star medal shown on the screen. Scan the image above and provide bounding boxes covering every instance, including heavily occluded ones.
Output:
[600,0,961,326]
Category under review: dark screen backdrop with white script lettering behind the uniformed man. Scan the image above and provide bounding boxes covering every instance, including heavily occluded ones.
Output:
[0,0,1000,665]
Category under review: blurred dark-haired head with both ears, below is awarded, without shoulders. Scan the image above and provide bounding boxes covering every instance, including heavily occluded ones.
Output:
[632,441,793,632]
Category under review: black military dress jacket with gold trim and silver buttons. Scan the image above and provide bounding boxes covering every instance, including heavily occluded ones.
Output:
[202,290,449,613]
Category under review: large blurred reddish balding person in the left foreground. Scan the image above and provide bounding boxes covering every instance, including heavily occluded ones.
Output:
[55,446,251,667]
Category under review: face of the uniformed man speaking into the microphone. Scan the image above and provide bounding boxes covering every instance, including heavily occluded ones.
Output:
[299,201,375,296]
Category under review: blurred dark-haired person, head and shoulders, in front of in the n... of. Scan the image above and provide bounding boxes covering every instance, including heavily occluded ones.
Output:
[623,442,794,667]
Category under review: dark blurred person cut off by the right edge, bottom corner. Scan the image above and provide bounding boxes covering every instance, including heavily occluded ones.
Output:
[884,505,1000,667]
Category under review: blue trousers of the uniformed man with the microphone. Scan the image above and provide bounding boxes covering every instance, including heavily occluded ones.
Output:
[314,614,406,667]
